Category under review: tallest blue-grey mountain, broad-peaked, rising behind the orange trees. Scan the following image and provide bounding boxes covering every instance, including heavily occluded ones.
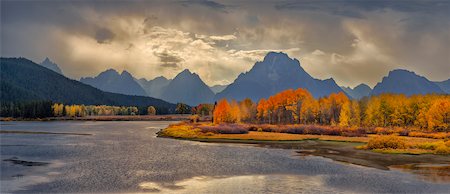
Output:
[215,52,343,101]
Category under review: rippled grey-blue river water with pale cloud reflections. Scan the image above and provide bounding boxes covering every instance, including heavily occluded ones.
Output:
[0,121,450,193]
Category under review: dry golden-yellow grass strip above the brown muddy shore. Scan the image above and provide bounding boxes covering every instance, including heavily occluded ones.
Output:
[159,122,450,155]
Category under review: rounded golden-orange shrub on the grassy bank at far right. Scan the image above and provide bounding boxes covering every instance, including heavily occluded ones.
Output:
[367,135,408,149]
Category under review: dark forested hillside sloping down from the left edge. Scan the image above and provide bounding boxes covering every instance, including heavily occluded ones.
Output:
[0,58,176,114]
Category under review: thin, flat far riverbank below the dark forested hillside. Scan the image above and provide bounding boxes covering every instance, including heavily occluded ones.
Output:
[0,114,191,121]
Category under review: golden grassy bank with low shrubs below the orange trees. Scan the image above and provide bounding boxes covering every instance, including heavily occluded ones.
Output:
[158,122,450,155]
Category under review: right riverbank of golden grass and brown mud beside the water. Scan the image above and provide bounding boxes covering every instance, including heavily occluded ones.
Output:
[158,123,450,170]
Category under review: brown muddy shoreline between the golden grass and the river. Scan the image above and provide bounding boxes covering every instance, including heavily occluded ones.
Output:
[158,134,450,170]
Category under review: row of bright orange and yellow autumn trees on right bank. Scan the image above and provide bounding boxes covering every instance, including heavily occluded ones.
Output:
[213,88,450,131]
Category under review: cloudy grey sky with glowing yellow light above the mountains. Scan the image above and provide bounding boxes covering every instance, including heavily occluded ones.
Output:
[0,0,450,87]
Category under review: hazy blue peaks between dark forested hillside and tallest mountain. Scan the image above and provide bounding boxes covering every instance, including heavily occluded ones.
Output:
[80,69,214,106]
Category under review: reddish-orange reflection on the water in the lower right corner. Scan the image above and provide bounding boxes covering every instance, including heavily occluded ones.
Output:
[390,163,450,183]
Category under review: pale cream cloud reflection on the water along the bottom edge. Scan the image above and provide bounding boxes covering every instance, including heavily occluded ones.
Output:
[139,174,343,193]
